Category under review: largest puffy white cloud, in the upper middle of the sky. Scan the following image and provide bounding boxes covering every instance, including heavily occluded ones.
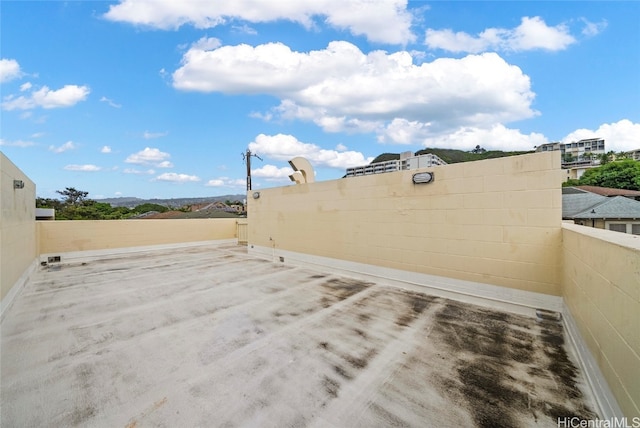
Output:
[173,42,537,143]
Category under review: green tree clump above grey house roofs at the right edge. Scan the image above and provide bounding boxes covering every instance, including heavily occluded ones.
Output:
[579,159,640,190]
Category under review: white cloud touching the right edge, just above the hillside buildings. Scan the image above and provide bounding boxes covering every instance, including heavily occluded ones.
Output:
[562,119,640,152]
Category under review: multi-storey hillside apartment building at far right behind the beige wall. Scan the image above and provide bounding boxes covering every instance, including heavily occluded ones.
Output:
[536,138,606,179]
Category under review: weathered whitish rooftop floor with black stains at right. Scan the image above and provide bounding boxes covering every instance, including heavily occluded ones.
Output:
[0,244,596,428]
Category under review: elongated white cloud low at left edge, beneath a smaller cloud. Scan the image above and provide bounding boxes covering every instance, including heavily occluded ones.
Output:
[2,85,91,110]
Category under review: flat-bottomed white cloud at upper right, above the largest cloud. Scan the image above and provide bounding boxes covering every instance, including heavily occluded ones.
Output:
[425,16,576,53]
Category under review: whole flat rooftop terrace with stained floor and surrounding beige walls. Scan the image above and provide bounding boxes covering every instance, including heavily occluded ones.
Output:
[0,152,640,422]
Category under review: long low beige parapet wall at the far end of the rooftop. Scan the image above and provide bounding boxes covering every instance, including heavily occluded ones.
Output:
[37,218,237,254]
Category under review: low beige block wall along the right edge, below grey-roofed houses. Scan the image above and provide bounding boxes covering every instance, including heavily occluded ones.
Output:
[562,224,640,418]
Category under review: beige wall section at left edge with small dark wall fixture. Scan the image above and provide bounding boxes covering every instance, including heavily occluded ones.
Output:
[0,152,37,309]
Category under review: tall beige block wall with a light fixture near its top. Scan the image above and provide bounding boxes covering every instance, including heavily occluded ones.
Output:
[248,152,564,296]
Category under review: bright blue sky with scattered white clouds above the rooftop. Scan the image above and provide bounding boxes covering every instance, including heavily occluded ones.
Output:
[0,0,640,199]
